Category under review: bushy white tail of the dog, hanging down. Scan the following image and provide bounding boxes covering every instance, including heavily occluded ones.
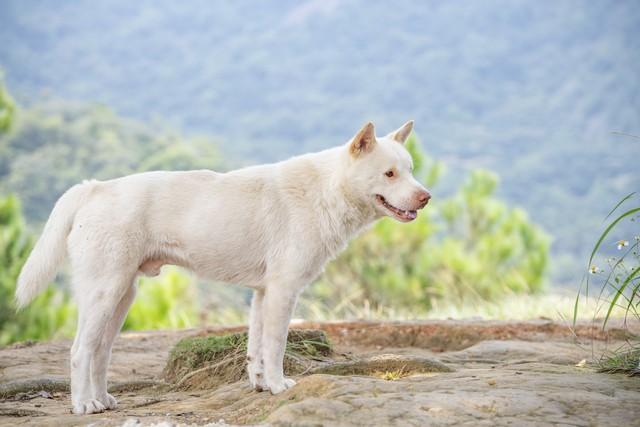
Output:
[16,181,95,309]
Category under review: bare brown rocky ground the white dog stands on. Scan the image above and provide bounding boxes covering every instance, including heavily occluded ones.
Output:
[0,321,640,426]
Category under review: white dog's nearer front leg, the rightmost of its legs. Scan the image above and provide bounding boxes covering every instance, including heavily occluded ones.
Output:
[262,283,301,394]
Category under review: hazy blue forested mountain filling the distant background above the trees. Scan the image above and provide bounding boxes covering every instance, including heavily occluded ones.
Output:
[0,0,640,281]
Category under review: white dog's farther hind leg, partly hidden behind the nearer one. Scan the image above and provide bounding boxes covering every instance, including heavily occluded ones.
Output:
[91,281,136,409]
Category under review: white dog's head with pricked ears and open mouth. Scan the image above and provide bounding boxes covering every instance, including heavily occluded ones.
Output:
[348,121,431,222]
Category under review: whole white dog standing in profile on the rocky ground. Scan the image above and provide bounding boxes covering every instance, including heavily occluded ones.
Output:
[16,121,431,414]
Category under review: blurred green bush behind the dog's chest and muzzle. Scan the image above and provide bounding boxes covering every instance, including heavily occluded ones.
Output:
[310,137,549,312]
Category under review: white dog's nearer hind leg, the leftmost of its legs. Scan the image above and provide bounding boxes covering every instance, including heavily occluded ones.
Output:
[71,271,133,414]
